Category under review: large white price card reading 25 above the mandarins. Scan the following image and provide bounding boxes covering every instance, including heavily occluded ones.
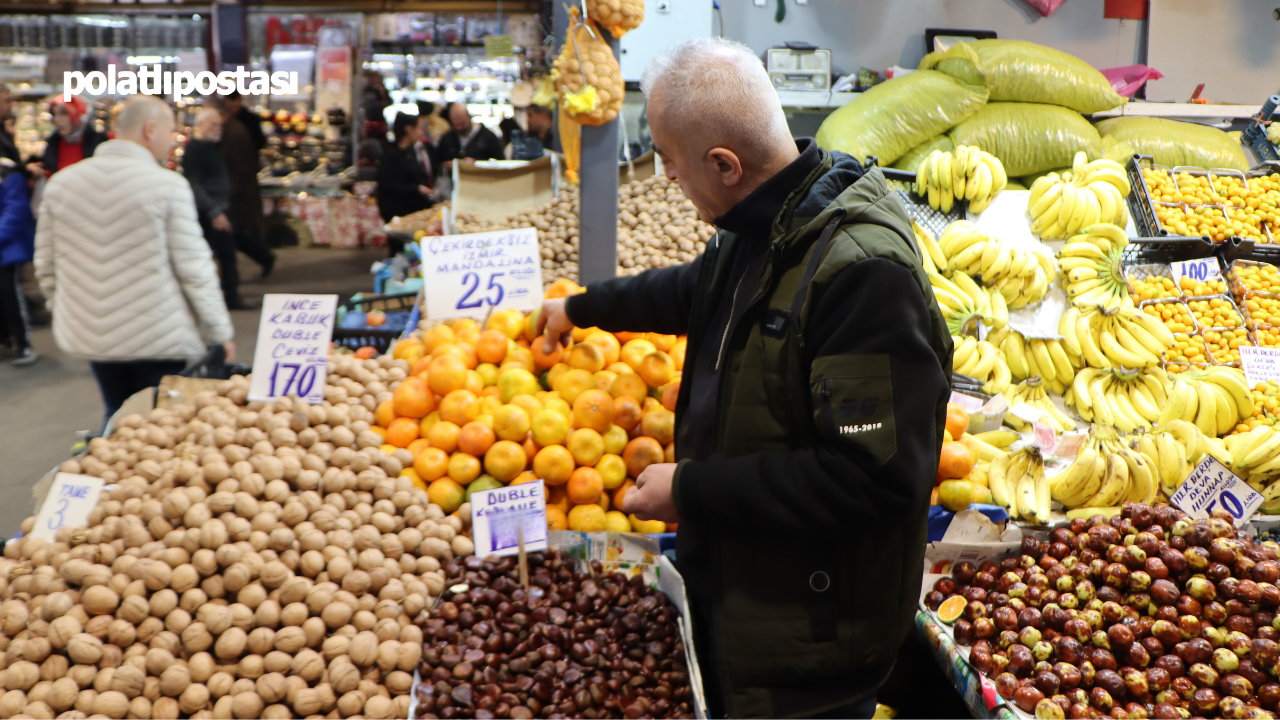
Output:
[422,228,543,320]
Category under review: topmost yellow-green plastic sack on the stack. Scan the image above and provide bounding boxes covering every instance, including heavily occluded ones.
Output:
[920,40,1125,113]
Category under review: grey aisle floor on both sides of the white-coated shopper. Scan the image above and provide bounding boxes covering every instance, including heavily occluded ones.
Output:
[0,247,387,537]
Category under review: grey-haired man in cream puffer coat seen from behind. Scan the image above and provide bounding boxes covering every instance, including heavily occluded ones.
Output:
[36,95,236,427]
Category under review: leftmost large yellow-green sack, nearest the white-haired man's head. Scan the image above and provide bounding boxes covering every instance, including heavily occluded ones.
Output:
[817,70,987,165]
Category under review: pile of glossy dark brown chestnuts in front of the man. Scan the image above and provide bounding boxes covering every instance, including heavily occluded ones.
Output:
[415,551,694,717]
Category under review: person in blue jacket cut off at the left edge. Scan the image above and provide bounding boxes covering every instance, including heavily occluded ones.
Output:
[0,158,37,366]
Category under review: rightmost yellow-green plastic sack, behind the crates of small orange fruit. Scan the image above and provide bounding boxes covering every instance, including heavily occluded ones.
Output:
[1098,118,1249,173]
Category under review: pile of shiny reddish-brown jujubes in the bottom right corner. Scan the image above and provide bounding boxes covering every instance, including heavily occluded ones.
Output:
[925,503,1280,719]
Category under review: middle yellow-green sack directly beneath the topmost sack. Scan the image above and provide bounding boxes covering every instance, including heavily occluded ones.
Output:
[948,102,1102,178]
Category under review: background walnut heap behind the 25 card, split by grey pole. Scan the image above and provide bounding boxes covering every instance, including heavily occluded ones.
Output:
[454,176,716,284]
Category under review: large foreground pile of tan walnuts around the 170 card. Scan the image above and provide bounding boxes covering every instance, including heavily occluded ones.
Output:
[0,356,474,719]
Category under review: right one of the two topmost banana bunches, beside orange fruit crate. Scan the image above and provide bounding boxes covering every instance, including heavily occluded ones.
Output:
[1027,152,1129,240]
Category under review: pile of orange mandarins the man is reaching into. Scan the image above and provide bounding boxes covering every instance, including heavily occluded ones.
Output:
[374,279,685,533]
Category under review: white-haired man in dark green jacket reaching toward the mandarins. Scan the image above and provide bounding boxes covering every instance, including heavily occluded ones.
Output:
[539,38,951,717]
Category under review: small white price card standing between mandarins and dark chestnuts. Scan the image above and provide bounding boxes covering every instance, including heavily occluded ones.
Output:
[470,480,547,557]
